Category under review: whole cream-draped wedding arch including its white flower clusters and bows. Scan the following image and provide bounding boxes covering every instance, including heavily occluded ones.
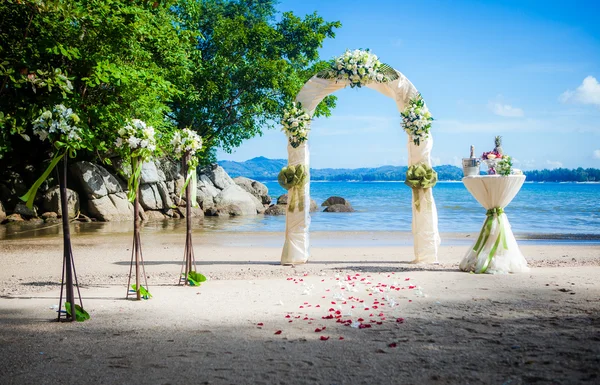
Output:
[279,50,440,265]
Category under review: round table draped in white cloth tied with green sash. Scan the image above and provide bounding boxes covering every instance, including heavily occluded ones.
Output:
[460,175,529,274]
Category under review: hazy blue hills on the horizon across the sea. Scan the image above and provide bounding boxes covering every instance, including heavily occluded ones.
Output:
[219,156,463,182]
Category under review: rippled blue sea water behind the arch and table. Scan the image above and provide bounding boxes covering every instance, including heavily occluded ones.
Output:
[253,182,600,235]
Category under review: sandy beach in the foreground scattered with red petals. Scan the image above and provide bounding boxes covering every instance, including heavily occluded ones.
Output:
[0,231,600,384]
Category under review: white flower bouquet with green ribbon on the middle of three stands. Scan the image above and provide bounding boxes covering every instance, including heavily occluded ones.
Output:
[115,119,156,202]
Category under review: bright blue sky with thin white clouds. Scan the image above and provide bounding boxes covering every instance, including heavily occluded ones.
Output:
[218,0,600,170]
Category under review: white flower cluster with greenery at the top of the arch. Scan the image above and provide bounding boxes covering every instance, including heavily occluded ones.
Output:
[327,49,390,88]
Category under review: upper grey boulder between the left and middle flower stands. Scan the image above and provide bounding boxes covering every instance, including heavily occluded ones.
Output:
[71,161,123,199]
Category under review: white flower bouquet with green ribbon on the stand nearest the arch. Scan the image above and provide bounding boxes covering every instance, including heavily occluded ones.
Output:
[171,128,202,207]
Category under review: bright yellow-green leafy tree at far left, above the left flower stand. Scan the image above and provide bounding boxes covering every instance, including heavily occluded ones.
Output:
[0,0,194,172]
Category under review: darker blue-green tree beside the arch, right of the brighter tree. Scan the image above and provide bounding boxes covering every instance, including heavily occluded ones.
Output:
[169,0,340,160]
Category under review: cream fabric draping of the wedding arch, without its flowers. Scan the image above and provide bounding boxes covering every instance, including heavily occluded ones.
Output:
[281,71,440,265]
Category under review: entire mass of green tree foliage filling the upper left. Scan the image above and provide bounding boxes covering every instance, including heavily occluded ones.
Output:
[0,0,340,176]
